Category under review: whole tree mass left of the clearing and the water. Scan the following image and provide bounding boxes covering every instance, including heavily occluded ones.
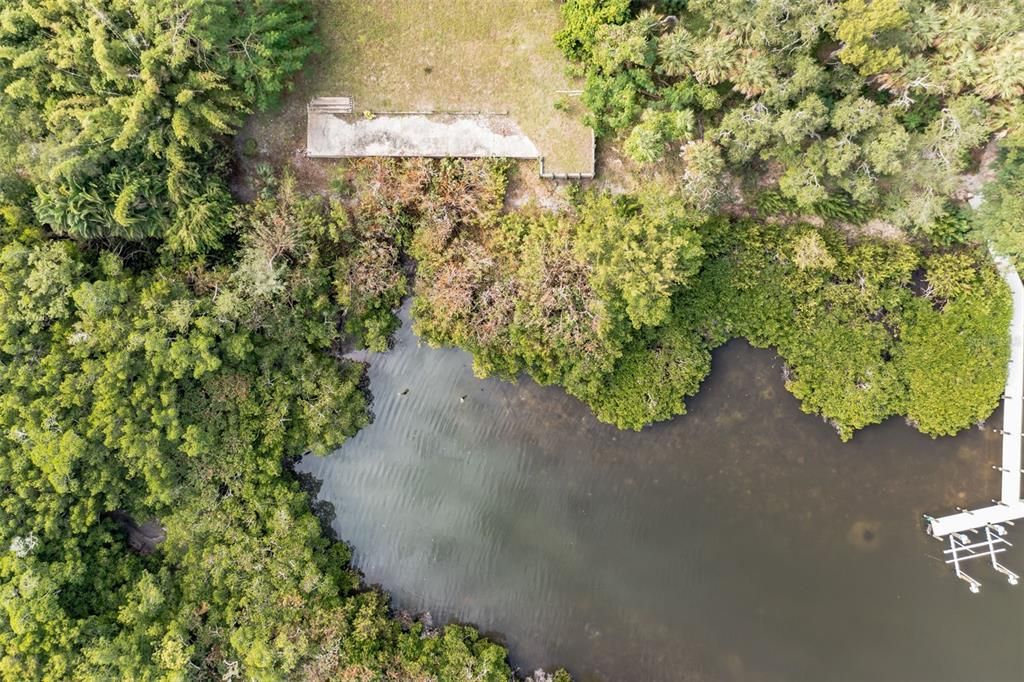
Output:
[0,6,544,681]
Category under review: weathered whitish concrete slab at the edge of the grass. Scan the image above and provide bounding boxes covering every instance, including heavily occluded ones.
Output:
[306,109,541,159]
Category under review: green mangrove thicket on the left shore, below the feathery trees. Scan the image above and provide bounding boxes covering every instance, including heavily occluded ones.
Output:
[0,188,524,680]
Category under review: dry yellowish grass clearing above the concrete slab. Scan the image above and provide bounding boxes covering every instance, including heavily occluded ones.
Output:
[243,0,591,175]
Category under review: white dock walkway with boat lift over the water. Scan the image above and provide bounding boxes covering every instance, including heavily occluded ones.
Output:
[925,256,1024,594]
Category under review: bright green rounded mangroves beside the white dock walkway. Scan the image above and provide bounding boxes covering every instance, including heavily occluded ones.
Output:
[681,225,1010,439]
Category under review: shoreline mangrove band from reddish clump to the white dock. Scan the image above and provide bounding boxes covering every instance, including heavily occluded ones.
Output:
[405,167,1010,439]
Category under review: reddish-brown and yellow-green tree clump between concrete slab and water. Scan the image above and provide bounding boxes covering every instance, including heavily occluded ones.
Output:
[399,163,706,411]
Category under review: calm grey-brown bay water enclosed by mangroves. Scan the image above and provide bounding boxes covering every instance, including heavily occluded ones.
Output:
[297,306,1024,682]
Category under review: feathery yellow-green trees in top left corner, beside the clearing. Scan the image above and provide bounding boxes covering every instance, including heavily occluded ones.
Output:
[0,0,311,252]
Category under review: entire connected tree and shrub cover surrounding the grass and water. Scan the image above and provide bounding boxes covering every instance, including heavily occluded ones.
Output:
[0,0,1024,680]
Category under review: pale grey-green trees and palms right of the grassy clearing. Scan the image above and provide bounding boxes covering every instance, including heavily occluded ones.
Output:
[563,0,1024,237]
